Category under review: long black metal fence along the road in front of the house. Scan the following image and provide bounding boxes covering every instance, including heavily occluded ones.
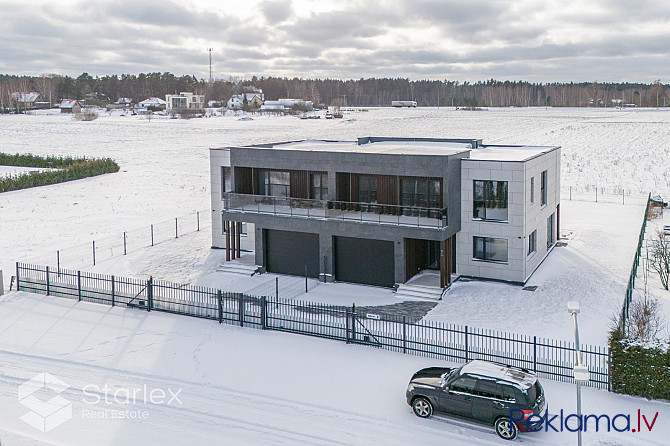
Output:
[16,263,610,389]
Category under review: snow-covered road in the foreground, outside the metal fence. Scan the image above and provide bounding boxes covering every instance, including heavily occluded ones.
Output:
[0,293,670,446]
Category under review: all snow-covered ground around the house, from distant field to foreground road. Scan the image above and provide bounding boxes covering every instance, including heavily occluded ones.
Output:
[0,108,670,445]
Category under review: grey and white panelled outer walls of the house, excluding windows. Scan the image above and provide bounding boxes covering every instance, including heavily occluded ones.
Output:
[210,139,560,283]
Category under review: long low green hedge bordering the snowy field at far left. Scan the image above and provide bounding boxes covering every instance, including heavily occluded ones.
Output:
[0,153,119,192]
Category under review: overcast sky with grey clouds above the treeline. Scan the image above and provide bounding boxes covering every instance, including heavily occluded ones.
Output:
[0,0,670,83]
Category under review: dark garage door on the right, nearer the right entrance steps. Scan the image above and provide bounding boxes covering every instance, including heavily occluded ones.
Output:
[334,237,395,287]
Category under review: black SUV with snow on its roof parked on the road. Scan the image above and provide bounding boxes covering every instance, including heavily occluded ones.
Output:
[407,360,547,440]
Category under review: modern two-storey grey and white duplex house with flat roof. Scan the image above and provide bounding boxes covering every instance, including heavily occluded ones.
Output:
[210,137,560,287]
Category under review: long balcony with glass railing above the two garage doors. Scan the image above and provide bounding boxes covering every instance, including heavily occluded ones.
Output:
[223,192,447,229]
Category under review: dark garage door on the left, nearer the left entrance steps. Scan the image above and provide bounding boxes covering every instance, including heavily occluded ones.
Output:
[264,229,319,277]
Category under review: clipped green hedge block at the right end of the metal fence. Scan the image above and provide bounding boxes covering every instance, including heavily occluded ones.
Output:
[610,331,670,399]
